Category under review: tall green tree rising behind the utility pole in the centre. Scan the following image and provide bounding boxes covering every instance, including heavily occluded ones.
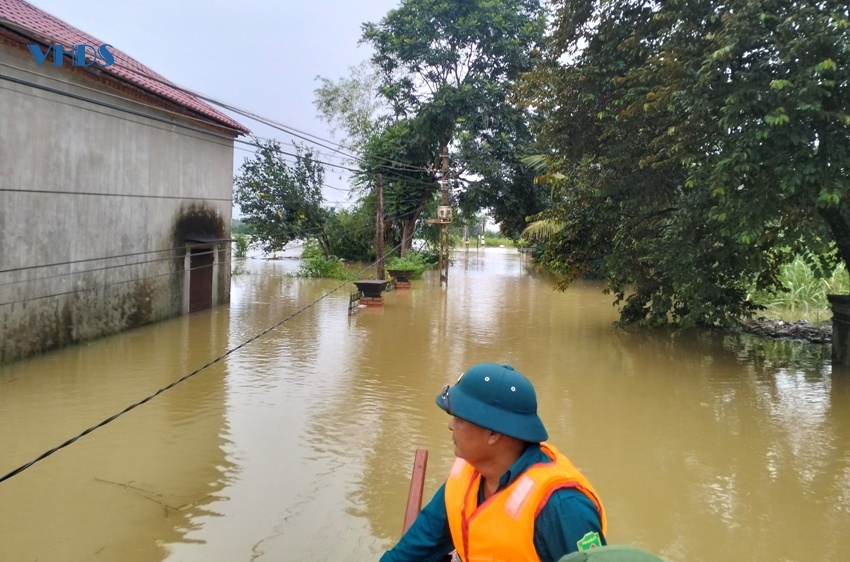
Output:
[362,0,545,240]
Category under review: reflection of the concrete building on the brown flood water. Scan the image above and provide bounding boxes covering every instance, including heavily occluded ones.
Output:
[0,309,231,561]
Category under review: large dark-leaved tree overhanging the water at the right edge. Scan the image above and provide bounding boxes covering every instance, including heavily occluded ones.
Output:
[524,0,850,324]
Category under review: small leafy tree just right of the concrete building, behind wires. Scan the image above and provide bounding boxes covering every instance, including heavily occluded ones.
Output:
[233,140,331,257]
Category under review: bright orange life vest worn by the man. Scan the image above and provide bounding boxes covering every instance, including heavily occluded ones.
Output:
[445,443,608,562]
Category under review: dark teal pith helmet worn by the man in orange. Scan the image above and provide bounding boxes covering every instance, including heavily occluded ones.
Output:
[436,363,548,443]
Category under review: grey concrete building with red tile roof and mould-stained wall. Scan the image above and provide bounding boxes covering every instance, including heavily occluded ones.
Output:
[0,0,249,362]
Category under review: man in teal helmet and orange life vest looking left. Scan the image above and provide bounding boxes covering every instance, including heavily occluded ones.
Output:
[381,363,607,562]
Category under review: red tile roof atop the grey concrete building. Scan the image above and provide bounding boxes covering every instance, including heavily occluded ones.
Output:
[0,0,250,133]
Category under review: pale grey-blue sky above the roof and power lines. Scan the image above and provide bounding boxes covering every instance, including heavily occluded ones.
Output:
[28,0,401,205]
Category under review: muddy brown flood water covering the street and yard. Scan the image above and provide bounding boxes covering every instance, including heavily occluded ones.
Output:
[0,249,850,562]
